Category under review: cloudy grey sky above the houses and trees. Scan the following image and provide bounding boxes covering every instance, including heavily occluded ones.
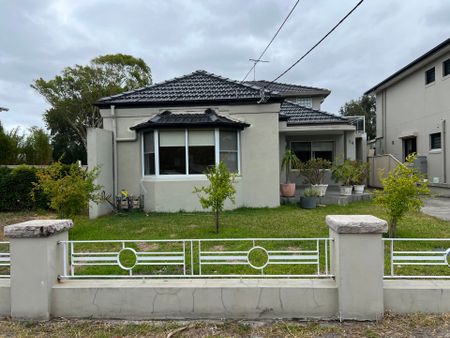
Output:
[0,0,450,130]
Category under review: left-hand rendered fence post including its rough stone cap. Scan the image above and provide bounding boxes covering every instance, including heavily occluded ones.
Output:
[5,220,73,320]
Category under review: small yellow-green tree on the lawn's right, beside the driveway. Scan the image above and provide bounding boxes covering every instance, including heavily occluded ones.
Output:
[375,154,430,238]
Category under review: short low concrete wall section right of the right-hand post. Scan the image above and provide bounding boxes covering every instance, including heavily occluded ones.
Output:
[384,280,450,314]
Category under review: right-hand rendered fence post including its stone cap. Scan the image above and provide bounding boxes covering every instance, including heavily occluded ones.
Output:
[326,215,387,320]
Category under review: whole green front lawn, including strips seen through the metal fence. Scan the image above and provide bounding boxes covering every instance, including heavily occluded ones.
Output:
[65,202,450,275]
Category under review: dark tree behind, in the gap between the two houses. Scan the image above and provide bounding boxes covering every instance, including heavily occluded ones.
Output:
[339,95,377,140]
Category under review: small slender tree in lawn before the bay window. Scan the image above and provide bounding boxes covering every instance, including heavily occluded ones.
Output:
[194,162,236,233]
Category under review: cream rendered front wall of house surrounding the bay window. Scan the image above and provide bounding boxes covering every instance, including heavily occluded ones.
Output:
[96,104,280,212]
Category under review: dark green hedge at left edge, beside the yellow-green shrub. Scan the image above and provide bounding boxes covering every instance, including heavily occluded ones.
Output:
[0,165,48,211]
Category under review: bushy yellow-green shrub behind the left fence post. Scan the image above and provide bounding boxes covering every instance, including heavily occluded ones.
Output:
[33,162,101,217]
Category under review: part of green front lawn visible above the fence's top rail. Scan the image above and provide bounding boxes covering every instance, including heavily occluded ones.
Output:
[70,202,450,240]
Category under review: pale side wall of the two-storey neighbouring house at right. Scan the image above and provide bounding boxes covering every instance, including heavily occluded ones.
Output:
[376,47,450,182]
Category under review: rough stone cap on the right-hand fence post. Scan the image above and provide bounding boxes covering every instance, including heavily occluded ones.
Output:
[325,215,388,234]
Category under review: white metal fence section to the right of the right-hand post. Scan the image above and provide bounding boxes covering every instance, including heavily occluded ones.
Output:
[384,238,450,279]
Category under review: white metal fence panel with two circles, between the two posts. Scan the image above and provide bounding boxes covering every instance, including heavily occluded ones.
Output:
[59,238,333,279]
